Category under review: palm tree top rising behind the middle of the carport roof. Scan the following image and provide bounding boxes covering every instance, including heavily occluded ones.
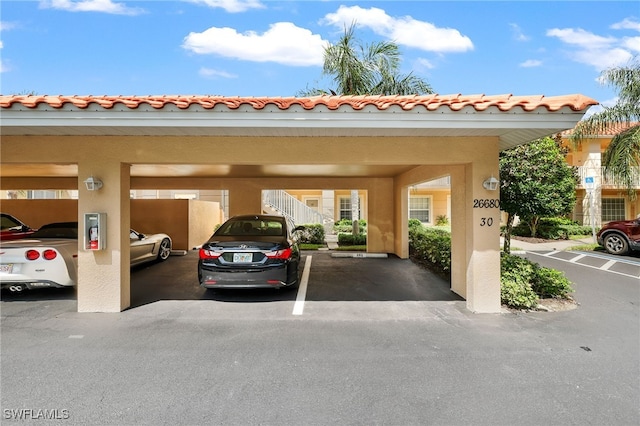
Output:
[298,23,433,96]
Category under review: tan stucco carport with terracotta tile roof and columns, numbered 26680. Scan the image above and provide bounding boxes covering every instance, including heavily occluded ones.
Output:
[0,95,597,312]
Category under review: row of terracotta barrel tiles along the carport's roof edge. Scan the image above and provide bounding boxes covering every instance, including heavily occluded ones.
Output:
[0,94,598,111]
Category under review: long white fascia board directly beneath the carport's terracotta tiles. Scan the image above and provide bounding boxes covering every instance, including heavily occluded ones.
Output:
[2,106,584,133]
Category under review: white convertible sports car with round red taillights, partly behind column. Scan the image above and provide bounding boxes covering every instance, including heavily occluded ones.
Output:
[0,222,171,291]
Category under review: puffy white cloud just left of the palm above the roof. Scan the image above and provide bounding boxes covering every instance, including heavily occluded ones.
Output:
[182,22,326,66]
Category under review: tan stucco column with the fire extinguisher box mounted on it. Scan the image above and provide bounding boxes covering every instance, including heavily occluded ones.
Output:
[78,161,131,312]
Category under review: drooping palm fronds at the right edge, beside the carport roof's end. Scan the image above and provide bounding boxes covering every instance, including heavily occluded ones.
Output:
[572,57,640,200]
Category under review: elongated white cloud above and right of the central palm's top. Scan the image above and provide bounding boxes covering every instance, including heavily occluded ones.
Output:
[320,6,473,53]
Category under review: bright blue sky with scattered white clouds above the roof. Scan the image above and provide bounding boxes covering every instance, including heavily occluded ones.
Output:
[0,0,640,110]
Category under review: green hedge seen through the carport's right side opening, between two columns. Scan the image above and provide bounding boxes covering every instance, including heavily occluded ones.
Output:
[409,226,451,271]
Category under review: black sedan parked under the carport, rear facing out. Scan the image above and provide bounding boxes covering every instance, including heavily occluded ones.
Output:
[198,215,304,288]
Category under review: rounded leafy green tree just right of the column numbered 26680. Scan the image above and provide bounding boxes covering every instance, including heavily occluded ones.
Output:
[500,137,578,254]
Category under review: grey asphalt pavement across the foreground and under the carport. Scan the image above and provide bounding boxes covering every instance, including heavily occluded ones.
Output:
[0,252,640,426]
